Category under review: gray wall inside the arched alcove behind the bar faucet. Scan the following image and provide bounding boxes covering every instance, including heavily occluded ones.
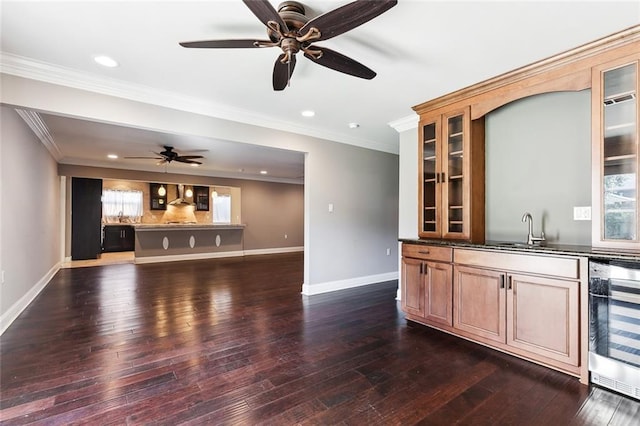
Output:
[485,90,591,245]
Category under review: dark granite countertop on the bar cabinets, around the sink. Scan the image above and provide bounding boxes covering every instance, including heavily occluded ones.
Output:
[399,238,640,262]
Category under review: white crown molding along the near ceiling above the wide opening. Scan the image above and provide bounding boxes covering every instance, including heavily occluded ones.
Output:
[0,52,398,154]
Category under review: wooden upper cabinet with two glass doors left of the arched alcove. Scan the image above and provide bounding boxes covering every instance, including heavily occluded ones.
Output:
[418,107,484,242]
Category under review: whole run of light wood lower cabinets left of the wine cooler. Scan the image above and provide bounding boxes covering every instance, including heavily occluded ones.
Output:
[401,243,588,383]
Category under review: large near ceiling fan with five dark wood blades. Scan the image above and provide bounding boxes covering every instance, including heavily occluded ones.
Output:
[180,0,398,90]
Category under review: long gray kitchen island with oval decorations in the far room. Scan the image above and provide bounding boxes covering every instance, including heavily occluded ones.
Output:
[135,223,245,263]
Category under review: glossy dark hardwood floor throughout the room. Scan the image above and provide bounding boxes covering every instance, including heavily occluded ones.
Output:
[0,253,640,425]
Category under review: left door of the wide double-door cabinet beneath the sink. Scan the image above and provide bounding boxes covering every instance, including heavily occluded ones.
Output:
[453,266,506,343]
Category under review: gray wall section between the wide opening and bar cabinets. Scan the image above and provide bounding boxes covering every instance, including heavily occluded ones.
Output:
[305,138,398,283]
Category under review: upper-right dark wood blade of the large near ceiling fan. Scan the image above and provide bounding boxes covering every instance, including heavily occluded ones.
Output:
[299,0,398,41]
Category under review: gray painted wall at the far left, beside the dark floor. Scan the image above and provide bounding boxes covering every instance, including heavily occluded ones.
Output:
[0,106,62,316]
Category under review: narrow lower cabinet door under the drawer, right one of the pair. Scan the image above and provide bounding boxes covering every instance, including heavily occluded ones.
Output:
[424,262,453,326]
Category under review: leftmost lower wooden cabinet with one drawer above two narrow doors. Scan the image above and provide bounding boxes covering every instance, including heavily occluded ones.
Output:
[401,244,453,326]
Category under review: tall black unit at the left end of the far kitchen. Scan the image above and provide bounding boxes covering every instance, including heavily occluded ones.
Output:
[71,177,102,260]
